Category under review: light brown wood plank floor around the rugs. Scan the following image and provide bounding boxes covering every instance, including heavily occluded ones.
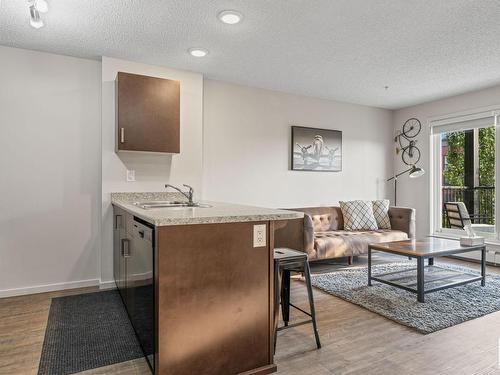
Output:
[0,257,500,375]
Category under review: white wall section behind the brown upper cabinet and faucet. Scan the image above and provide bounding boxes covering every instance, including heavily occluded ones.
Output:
[101,57,203,283]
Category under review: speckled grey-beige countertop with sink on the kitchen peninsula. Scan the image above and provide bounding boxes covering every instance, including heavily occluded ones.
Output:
[111,192,304,226]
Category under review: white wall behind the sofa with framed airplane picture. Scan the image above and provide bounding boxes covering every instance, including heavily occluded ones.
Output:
[203,80,393,207]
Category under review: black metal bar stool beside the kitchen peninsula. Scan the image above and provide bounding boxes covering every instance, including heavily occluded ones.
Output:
[274,247,321,351]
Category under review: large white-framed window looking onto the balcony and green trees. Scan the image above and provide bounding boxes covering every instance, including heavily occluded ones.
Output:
[430,110,499,238]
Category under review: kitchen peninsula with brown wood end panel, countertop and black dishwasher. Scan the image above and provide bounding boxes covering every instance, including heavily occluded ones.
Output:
[112,193,303,375]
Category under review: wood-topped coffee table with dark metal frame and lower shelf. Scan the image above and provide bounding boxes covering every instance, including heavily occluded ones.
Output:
[368,237,486,302]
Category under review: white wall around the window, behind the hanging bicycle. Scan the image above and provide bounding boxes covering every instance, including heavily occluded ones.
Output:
[393,86,500,236]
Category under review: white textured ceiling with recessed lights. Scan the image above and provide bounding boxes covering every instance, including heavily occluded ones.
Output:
[0,0,500,109]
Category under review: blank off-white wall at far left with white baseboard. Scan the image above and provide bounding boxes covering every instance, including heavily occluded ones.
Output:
[0,46,101,297]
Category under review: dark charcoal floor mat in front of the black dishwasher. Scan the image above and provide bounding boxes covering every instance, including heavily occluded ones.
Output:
[38,290,143,375]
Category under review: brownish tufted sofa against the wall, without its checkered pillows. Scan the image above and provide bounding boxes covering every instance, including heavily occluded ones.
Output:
[291,207,415,264]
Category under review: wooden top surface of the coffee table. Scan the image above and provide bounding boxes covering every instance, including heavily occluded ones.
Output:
[370,237,485,258]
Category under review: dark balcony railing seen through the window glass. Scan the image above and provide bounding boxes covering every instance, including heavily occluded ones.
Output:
[442,186,495,228]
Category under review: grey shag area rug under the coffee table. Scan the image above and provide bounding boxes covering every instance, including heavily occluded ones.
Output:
[311,262,500,334]
